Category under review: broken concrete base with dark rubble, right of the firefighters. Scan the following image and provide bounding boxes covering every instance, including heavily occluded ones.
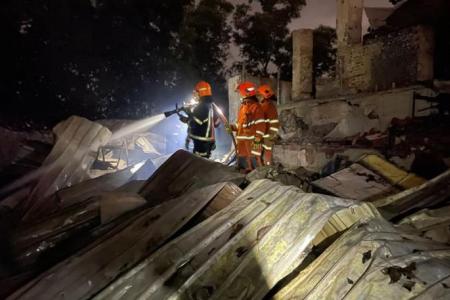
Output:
[274,87,450,179]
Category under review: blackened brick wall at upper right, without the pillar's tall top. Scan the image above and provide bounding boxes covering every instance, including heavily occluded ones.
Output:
[338,26,434,93]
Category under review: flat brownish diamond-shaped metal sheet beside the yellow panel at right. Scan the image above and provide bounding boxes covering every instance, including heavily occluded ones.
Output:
[313,163,398,201]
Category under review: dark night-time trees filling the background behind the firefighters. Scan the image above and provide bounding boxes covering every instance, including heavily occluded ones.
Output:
[0,0,334,124]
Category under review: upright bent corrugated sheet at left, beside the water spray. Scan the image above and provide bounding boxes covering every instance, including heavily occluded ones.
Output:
[20,116,112,219]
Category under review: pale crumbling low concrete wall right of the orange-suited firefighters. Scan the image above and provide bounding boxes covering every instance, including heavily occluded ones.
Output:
[274,87,433,172]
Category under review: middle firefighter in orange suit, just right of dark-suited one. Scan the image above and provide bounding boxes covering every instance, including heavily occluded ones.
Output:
[227,82,266,173]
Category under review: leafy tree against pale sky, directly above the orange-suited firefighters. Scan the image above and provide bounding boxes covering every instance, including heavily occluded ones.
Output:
[233,0,305,79]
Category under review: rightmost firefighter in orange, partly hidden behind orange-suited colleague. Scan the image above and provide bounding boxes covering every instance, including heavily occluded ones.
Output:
[258,84,280,166]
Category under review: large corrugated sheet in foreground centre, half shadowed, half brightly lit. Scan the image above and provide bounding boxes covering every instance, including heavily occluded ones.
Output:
[96,180,378,299]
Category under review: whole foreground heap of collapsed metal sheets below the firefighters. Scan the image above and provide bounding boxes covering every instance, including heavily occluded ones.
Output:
[0,113,450,300]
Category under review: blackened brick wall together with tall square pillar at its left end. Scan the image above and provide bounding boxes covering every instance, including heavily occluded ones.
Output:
[336,0,435,94]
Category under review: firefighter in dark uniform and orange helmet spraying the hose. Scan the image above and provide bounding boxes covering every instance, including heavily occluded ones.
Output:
[179,81,220,158]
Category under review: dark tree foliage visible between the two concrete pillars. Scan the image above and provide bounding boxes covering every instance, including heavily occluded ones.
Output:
[314,25,336,77]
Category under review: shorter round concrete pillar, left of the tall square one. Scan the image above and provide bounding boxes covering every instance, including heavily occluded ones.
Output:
[292,29,314,101]
